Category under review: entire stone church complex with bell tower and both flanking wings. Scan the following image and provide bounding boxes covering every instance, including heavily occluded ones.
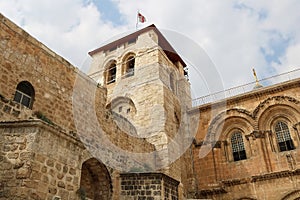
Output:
[0,15,300,200]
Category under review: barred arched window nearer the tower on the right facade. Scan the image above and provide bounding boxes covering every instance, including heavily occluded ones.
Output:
[231,132,247,161]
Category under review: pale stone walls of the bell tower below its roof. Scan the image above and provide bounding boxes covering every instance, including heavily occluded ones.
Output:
[89,21,191,184]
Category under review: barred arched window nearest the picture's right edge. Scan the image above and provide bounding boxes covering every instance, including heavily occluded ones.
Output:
[275,121,295,151]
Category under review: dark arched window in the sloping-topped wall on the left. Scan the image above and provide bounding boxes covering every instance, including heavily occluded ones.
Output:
[14,81,34,108]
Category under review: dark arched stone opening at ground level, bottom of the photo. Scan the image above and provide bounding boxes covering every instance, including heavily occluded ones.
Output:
[79,158,112,200]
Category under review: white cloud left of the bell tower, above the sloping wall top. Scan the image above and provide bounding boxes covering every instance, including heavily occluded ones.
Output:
[0,0,126,67]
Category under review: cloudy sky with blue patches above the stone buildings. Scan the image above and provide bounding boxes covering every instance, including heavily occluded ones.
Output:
[0,0,300,97]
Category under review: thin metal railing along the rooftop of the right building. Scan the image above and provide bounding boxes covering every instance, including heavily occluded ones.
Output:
[192,68,300,107]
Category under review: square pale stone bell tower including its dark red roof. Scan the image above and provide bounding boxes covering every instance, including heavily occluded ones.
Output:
[89,25,191,178]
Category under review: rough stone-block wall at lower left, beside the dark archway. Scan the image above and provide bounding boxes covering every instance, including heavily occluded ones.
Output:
[0,120,84,199]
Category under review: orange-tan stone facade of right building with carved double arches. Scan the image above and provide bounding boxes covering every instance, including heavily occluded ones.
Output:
[190,79,300,199]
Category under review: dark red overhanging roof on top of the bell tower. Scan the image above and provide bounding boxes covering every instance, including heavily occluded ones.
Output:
[89,24,186,67]
